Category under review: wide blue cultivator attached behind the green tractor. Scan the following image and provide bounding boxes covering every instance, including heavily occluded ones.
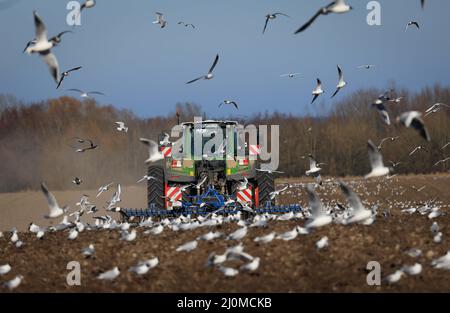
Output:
[121,186,303,220]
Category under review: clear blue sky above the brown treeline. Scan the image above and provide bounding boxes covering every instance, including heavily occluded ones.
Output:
[0,0,450,117]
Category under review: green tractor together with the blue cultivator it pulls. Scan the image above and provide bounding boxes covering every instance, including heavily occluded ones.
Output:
[122,120,301,219]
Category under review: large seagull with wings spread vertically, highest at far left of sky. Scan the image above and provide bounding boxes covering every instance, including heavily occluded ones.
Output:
[25,11,60,83]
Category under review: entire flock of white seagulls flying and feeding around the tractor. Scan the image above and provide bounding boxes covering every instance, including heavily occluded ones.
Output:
[0,0,450,290]
